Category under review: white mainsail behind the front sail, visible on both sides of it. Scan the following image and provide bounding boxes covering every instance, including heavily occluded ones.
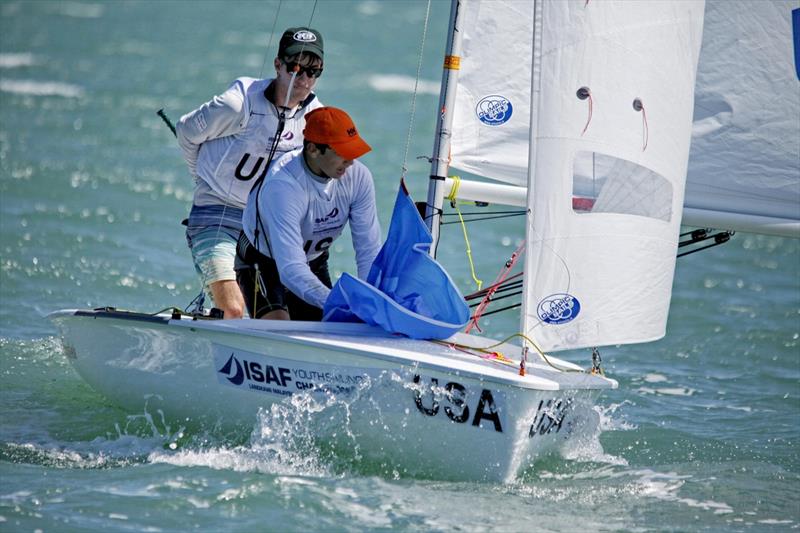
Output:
[451,0,800,237]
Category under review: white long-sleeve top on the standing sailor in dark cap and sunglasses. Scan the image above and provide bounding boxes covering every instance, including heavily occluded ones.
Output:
[175,78,322,209]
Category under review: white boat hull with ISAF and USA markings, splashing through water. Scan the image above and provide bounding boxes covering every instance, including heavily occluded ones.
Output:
[50,310,617,481]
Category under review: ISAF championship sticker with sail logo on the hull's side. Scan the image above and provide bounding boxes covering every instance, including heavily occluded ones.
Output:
[213,344,368,396]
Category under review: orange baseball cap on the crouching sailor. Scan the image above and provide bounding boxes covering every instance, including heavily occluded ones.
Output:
[303,107,372,159]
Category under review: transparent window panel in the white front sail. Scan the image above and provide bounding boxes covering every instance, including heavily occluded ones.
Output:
[572,151,673,222]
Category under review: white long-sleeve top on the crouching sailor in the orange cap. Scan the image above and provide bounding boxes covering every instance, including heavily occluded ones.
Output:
[243,149,381,308]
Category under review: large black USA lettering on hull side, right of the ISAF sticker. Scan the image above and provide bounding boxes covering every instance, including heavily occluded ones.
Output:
[413,374,505,433]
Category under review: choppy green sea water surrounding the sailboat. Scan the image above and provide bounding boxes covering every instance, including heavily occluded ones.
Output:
[0,0,800,532]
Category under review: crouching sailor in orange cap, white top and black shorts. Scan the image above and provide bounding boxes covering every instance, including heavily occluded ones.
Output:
[236,107,381,320]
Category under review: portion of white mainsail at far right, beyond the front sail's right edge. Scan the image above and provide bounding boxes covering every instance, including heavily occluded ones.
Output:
[685,0,800,236]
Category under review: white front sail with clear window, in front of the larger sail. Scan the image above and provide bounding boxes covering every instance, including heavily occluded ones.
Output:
[522,0,703,350]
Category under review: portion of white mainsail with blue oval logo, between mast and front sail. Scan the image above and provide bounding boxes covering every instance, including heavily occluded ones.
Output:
[450,0,534,186]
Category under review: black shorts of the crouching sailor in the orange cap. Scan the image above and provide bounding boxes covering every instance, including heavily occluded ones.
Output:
[235,232,332,321]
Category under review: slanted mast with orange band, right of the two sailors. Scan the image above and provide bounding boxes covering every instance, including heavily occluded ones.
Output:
[425,0,466,257]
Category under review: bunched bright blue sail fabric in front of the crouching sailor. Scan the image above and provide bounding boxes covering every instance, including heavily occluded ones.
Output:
[323,181,469,339]
